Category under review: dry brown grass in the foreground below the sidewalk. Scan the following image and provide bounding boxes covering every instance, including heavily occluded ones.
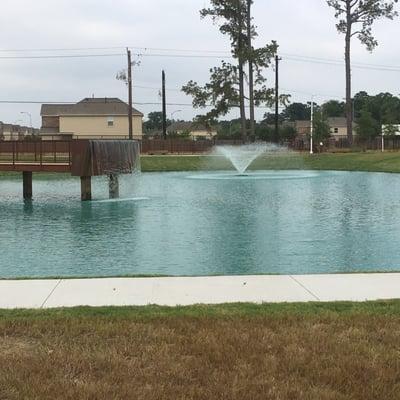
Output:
[0,303,400,400]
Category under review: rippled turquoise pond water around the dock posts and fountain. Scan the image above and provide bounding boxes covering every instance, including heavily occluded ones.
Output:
[0,171,400,278]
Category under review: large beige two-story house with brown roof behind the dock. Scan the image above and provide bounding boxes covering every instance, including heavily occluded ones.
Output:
[40,98,143,140]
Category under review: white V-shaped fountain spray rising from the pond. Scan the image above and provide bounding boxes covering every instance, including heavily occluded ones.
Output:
[216,142,282,175]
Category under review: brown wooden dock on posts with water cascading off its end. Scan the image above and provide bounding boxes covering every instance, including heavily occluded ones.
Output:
[0,140,140,201]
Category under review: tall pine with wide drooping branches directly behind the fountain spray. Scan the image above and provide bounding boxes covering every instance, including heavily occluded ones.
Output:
[182,0,287,140]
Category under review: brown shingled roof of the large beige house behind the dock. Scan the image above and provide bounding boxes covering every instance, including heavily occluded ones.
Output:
[40,97,143,117]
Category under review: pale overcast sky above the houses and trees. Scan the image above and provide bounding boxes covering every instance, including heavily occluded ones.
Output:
[0,0,400,127]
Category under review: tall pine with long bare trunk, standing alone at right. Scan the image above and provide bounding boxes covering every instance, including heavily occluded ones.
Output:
[327,0,397,143]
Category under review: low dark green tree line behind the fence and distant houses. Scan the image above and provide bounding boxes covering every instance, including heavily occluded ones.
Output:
[144,91,400,142]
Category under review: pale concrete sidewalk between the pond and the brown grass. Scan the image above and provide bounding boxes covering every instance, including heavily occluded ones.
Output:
[0,273,400,309]
